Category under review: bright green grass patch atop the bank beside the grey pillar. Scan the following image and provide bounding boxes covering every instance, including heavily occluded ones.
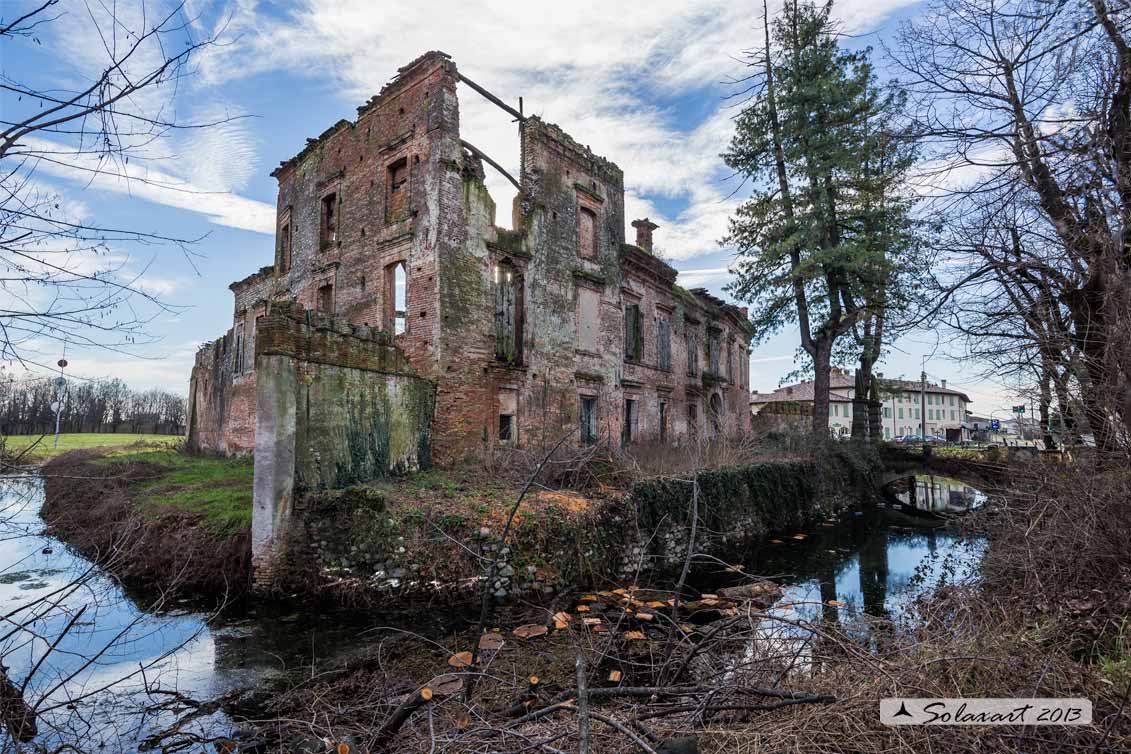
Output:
[100,450,254,534]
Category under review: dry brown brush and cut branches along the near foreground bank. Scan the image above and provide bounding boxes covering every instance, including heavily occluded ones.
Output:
[222,452,1131,754]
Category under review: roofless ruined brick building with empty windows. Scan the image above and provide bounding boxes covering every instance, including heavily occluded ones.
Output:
[189,52,750,465]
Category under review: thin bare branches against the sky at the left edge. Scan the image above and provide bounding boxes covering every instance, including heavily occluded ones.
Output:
[0,0,229,361]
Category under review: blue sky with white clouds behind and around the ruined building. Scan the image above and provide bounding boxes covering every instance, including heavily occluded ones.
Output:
[0,0,1009,413]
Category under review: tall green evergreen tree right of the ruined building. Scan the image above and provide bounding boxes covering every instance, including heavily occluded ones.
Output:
[723,0,906,434]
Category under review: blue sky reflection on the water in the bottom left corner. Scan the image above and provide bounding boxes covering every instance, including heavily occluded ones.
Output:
[0,477,242,752]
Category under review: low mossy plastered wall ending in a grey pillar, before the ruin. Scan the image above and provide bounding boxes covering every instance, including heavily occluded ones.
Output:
[251,302,434,584]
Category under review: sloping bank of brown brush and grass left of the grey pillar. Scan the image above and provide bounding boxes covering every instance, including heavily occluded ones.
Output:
[42,449,253,598]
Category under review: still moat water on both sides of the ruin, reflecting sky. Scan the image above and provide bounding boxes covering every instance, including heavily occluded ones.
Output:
[0,477,983,753]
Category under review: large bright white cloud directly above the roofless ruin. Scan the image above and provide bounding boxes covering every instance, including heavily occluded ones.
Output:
[185,0,917,248]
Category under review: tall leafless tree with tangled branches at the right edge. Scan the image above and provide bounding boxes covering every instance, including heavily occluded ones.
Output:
[895,0,1131,451]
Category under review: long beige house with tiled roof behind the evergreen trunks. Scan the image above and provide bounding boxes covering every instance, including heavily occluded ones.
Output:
[750,369,970,440]
